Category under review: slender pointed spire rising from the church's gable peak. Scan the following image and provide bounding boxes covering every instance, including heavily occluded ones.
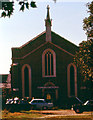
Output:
[45,5,52,42]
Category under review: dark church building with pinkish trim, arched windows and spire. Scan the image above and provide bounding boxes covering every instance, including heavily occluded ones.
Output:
[11,6,80,105]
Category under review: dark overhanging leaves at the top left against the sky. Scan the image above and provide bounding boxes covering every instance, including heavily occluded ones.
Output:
[0,0,56,17]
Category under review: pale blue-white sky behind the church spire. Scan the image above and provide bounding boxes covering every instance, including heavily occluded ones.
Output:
[0,0,91,74]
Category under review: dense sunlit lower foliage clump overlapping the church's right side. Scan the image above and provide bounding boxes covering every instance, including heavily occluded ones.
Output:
[74,39,93,81]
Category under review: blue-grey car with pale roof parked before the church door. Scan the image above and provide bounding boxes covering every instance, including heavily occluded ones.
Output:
[29,99,53,110]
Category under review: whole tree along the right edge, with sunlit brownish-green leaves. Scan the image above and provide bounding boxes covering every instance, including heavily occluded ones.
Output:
[74,1,93,98]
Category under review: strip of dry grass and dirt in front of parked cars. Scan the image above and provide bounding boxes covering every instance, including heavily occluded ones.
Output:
[2,110,93,120]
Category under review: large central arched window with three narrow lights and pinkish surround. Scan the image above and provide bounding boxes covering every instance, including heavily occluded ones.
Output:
[42,49,56,77]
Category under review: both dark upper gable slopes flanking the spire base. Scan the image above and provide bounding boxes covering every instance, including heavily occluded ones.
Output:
[12,31,78,58]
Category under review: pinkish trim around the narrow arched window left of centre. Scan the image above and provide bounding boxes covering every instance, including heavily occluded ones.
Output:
[22,64,31,98]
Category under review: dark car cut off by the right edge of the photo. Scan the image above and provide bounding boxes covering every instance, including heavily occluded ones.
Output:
[73,100,93,113]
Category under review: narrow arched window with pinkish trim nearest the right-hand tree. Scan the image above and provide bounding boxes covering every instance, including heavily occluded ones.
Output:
[67,63,77,97]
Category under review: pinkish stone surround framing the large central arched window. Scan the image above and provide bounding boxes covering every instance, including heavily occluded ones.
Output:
[42,48,56,77]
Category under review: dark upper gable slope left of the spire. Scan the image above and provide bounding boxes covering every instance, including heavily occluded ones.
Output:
[12,31,45,58]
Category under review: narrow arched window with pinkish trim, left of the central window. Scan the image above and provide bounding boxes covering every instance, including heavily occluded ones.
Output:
[22,64,31,97]
